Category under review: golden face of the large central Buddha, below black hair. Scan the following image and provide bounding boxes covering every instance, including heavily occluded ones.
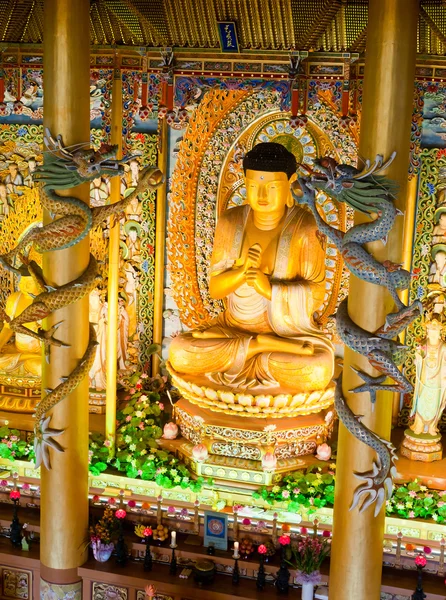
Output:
[245,169,290,213]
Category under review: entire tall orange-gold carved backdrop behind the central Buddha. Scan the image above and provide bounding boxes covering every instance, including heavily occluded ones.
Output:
[168,88,352,337]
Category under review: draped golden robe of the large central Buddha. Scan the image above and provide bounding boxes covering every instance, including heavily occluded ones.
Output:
[169,205,334,393]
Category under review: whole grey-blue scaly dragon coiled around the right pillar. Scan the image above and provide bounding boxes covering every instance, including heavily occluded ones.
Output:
[292,154,422,516]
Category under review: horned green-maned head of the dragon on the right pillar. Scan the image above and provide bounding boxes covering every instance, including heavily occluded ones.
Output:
[304,152,396,215]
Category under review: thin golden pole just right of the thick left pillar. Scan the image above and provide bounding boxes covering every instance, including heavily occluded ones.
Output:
[105,62,122,455]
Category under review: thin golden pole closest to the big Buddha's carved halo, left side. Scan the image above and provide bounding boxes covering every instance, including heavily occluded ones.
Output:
[152,119,169,376]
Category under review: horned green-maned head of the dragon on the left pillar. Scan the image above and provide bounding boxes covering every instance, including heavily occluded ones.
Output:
[35,129,139,189]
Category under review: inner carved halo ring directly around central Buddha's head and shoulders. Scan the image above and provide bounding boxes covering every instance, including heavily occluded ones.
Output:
[217,111,346,325]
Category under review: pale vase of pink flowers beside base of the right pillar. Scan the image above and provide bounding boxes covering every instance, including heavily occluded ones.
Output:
[288,531,331,600]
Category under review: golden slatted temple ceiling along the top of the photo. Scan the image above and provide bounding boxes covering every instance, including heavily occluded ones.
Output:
[0,0,446,55]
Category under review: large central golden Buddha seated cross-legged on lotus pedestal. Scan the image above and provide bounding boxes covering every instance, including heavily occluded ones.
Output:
[169,142,334,395]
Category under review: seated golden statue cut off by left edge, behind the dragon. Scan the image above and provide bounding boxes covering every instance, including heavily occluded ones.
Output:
[0,277,42,379]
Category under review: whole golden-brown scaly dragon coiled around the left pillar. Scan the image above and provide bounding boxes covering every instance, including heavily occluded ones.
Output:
[0,129,164,469]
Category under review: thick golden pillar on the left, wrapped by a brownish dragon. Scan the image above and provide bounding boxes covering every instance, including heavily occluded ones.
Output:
[40,0,90,598]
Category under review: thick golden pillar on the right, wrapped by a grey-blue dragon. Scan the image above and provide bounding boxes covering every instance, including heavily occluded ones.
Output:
[329,0,419,600]
